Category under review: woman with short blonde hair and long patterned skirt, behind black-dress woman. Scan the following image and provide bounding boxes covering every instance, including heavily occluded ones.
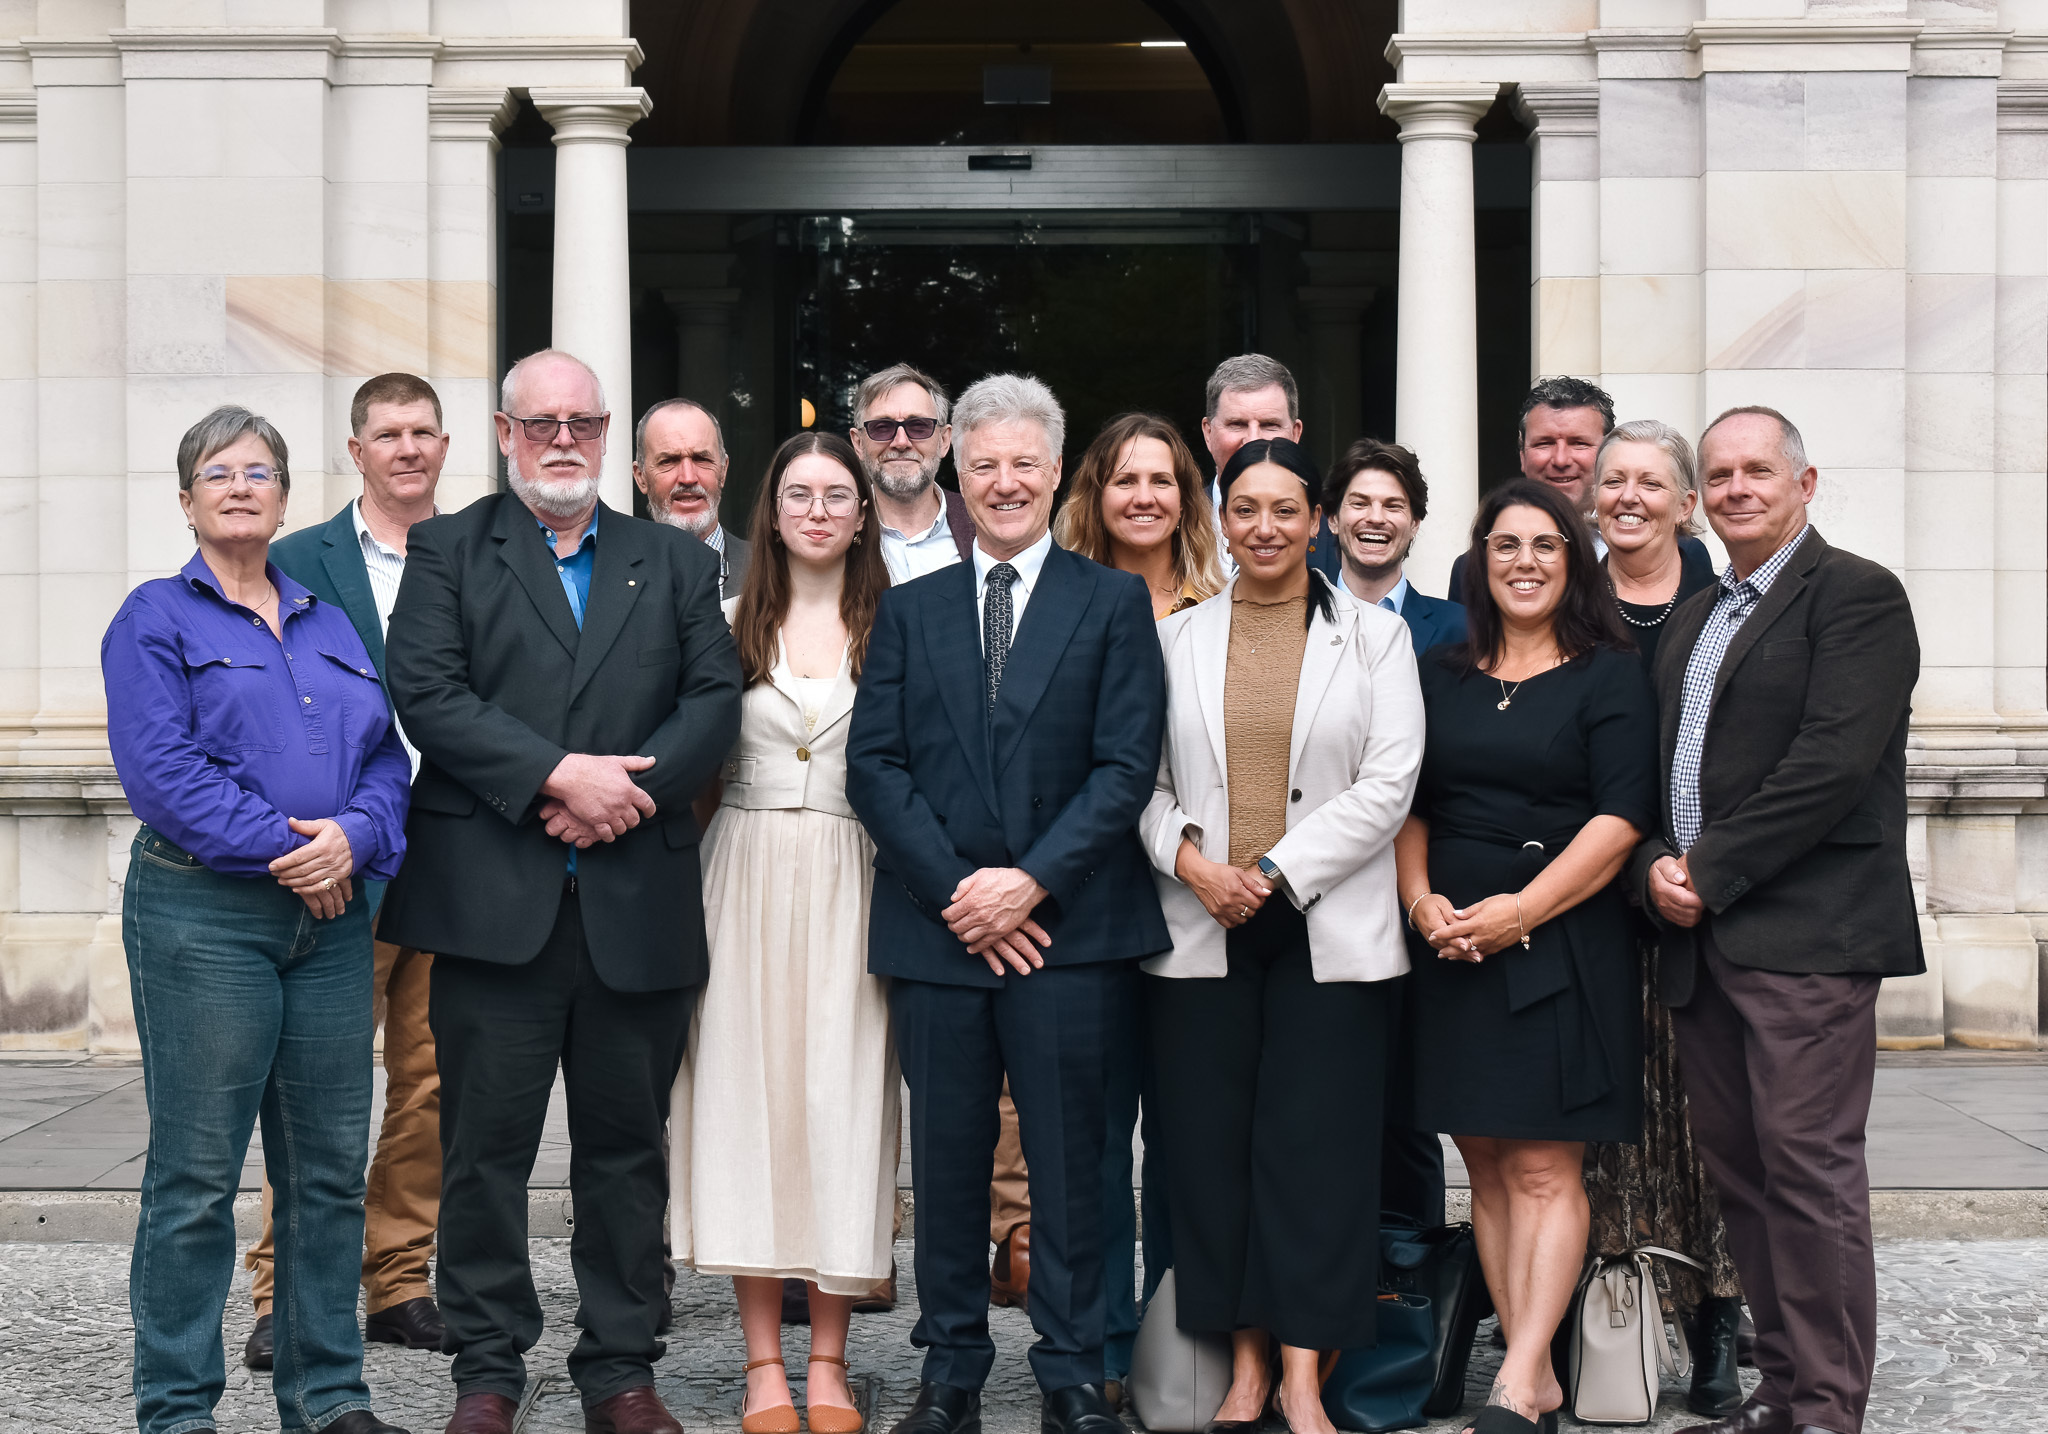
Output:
[1585,418,1743,1418]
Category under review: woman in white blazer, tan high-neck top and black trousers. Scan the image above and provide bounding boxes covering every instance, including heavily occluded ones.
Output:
[1141,438,1423,1434]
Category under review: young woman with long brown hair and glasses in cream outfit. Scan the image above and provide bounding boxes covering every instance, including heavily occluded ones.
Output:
[670,432,899,1434]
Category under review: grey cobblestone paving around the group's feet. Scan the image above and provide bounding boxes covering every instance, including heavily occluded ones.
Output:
[0,1239,2048,1434]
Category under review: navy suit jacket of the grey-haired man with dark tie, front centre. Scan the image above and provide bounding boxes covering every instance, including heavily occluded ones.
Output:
[846,545,1171,985]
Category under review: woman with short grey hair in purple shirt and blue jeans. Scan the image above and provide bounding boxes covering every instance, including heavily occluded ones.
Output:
[100,408,412,1434]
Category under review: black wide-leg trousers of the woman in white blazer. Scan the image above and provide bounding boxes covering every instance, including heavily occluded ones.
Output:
[1155,897,1399,1350]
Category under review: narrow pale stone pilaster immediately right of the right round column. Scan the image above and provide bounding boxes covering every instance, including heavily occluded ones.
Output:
[1516,82,1602,375]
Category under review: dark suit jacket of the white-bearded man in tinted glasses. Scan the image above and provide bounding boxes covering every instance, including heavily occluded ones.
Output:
[379,494,739,992]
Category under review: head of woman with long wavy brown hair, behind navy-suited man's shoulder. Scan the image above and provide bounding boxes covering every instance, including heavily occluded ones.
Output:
[1053,414,1223,617]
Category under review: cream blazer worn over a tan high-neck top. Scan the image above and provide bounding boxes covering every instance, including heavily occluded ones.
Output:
[1139,576,1423,981]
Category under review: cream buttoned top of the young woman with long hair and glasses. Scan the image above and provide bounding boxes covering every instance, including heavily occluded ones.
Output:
[719,598,856,817]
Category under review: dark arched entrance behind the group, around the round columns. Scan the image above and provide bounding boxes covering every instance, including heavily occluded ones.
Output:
[502,0,1530,520]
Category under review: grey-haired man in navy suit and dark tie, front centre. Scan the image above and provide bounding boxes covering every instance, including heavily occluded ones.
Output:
[846,373,1169,1434]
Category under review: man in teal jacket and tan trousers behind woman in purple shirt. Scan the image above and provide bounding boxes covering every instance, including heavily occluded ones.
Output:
[242,373,449,1368]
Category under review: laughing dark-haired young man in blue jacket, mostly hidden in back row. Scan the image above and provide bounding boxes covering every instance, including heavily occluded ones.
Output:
[1323,438,1464,1227]
